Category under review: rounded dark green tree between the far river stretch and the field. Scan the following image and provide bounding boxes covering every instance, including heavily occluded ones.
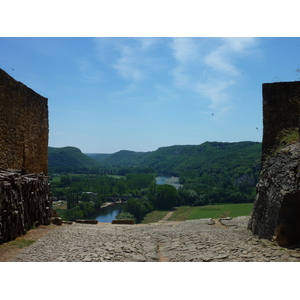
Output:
[155,184,179,210]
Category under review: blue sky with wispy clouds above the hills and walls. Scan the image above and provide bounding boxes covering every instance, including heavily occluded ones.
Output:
[0,37,300,153]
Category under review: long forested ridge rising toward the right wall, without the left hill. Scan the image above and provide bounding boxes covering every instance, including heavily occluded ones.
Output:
[88,142,261,177]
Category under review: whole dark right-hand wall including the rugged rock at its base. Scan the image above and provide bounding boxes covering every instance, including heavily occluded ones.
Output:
[248,81,300,246]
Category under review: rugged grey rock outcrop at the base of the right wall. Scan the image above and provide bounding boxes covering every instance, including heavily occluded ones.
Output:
[249,142,300,245]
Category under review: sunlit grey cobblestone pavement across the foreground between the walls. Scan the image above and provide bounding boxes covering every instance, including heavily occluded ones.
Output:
[11,217,300,262]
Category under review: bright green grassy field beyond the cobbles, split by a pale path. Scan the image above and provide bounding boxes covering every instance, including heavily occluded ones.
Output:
[142,203,253,224]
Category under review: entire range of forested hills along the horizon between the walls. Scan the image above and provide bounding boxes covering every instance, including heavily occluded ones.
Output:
[48,142,261,178]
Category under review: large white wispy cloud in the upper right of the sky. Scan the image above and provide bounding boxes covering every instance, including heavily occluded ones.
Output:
[171,38,257,115]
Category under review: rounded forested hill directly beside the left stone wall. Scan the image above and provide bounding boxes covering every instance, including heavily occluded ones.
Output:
[48,147,98,172]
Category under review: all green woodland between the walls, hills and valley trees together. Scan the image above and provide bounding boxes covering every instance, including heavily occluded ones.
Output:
[49,142,261,222]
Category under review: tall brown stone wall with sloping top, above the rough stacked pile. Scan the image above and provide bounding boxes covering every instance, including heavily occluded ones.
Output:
[0,69,49,175]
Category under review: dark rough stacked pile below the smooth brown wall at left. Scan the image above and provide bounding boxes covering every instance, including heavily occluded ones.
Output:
[0,169,52,244]
